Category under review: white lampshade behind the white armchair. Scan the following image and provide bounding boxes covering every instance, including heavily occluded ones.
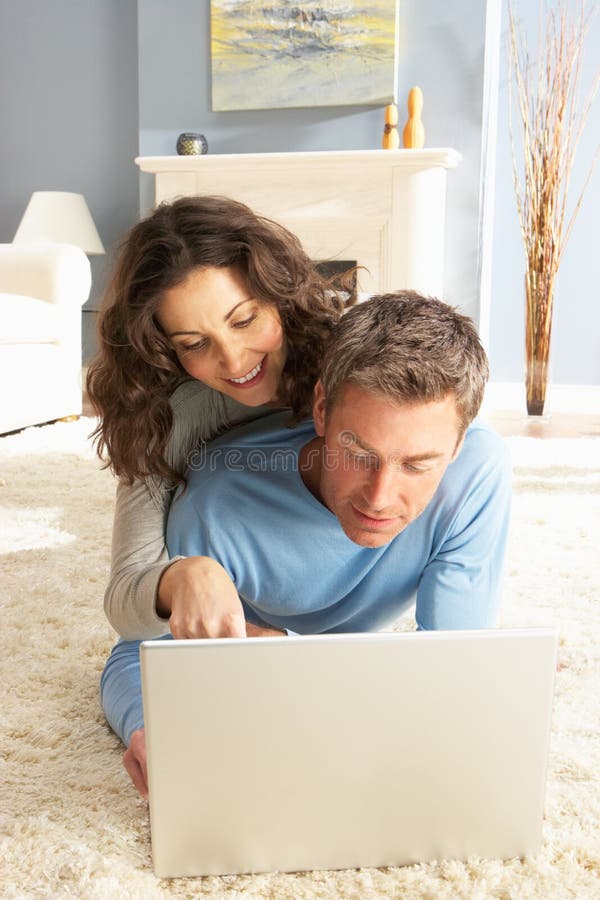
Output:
[13,191,106,254]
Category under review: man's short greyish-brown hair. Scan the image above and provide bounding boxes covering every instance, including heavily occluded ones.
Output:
[321,291,489,432]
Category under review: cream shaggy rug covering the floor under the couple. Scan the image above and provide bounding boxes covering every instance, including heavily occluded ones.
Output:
[0,419,600,900]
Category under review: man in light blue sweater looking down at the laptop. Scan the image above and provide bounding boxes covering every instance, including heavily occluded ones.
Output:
[102,292,511,795]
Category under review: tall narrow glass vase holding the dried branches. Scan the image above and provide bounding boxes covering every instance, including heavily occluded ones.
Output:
[525,270,554,416]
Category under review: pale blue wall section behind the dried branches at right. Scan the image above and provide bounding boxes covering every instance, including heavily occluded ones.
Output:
[489,0,600,385]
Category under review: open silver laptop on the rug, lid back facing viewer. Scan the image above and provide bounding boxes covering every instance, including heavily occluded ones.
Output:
[140,628,558,878]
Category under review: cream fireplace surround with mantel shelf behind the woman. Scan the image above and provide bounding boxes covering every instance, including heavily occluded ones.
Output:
[136,148,460,297]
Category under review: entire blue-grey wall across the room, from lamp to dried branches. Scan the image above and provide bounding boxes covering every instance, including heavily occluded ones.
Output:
[0,0,600,384]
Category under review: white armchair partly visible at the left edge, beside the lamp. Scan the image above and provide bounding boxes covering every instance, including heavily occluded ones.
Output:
[0,243,91,434]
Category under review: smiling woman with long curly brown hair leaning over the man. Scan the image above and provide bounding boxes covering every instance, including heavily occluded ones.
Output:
[87,196,354,639]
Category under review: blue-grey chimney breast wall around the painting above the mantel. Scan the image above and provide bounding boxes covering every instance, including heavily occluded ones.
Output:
[138,0,486,326]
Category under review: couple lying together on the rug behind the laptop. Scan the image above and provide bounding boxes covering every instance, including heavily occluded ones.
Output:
[88,197,511,796]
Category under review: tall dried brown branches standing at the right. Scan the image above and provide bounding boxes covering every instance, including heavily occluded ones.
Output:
[508,0,600,407]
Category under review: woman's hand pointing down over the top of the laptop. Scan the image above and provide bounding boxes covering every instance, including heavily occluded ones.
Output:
[156,556,246,638]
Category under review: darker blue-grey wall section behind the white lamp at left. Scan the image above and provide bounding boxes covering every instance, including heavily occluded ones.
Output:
[0,0,138,359]
